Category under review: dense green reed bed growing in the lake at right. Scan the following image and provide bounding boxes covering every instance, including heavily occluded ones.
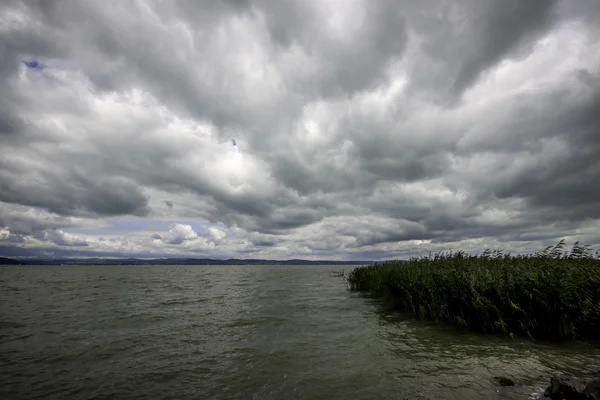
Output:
[347,240,600,340]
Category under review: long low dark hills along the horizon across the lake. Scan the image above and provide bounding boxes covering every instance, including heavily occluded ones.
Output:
[13,258,376,265]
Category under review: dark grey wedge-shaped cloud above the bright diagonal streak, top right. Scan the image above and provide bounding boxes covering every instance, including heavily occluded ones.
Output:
[400,0,568,106]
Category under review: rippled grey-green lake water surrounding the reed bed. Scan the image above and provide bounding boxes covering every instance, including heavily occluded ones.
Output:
[0,266,600,400]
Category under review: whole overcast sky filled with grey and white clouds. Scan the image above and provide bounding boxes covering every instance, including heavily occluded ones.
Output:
[0,0,600,260]
